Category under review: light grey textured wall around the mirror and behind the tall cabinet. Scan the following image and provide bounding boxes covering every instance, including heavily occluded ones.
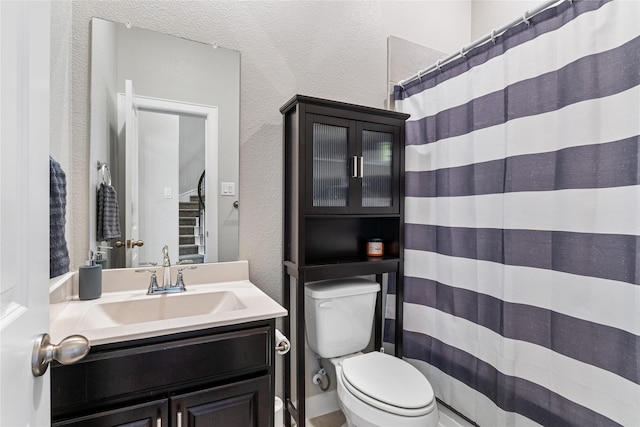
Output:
[52,0,471,404]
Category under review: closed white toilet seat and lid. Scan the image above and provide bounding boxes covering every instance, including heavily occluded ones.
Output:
[340,352,435,417]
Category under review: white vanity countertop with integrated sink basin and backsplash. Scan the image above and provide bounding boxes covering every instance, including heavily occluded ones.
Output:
[50,261,287,345]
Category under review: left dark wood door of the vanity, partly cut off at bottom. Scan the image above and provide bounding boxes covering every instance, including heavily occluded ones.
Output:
[52,399,169,427]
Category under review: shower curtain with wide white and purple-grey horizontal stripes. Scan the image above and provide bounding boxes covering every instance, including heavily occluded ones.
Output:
[390,0,640,427]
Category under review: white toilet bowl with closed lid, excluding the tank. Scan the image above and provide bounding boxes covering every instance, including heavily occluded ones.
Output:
[331,352,438,427]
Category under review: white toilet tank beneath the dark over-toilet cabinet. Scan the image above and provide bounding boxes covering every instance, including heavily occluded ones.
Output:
[304,277,380,358]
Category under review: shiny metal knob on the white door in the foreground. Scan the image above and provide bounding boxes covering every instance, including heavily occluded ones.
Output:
[31,334,91,377]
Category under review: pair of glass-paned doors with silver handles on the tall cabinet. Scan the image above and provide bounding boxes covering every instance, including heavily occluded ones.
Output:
[306,114,399,214]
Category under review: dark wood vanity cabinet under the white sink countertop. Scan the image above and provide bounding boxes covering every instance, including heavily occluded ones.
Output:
[51,319,275,427]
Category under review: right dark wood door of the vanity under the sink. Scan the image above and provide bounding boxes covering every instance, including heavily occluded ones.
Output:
[171,376,273,427]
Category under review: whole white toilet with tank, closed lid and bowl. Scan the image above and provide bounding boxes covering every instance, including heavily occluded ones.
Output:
[305,277,438,427]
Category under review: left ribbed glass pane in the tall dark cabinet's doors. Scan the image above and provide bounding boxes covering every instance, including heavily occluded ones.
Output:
[312,121,349,208]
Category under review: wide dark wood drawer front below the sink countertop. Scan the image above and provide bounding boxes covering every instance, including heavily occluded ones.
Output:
[51,326,273,417]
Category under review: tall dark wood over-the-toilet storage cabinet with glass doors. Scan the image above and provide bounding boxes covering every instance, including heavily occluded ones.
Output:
[280,95,409,426]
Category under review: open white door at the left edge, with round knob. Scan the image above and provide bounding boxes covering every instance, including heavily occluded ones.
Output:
[0,1,50,427]
